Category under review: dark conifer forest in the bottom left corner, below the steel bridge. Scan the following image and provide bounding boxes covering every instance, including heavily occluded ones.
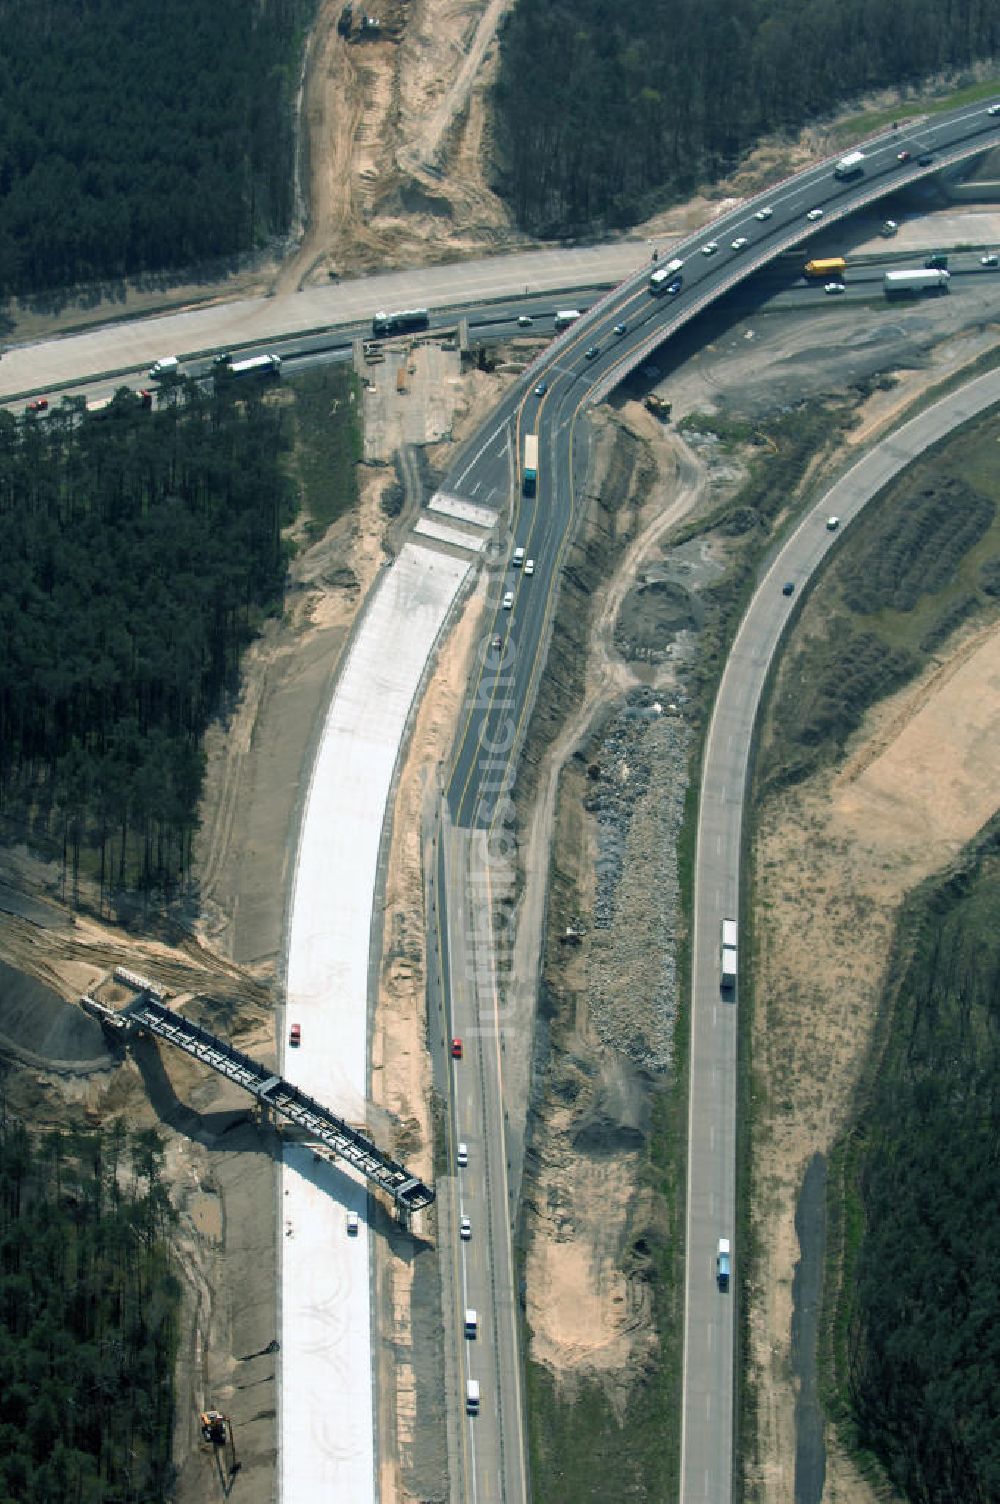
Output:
[0,1119,179,1504]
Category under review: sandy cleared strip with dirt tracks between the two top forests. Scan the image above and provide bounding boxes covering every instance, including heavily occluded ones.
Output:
[242,0,525,292]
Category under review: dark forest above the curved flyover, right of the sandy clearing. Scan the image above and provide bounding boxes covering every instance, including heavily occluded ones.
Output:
[495,0,1000,235]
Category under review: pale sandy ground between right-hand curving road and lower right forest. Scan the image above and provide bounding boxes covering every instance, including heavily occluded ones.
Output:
[752,608,1000,1504]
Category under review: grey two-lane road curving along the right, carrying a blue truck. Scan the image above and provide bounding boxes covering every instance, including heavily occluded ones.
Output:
[681,363,1000,1504]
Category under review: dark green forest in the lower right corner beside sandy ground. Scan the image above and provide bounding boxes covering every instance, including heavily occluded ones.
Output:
[838,821,1000,1504]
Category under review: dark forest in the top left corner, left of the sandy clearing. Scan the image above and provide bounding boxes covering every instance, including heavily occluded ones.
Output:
[0,0,314,296]
